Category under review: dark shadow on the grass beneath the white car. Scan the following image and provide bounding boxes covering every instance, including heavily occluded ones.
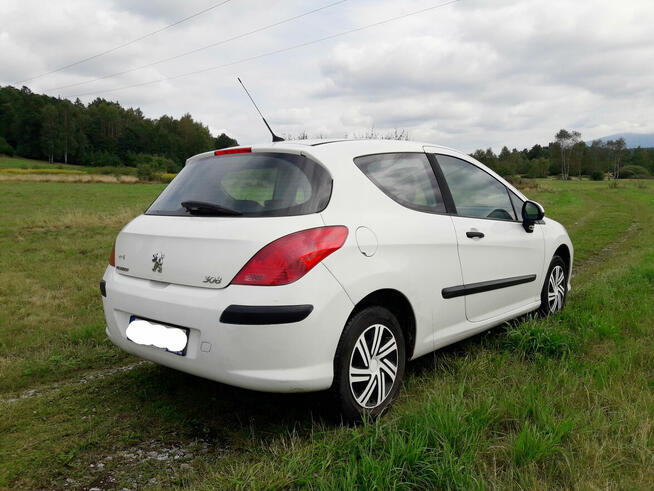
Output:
[105,318,522,445]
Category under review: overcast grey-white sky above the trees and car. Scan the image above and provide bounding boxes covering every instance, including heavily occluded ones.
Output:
[0,0,654,151]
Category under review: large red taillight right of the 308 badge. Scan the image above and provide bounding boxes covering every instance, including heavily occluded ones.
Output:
[232,225,347,286]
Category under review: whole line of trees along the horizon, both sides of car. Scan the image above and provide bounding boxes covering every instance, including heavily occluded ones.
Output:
[0,86,654,179]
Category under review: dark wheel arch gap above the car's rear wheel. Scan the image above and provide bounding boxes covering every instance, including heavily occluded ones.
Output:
[347,288,416,361]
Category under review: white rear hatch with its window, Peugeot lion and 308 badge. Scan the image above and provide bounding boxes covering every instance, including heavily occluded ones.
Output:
[115,149,332,288]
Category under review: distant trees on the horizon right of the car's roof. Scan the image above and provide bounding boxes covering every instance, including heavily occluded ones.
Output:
[471,129,654,180]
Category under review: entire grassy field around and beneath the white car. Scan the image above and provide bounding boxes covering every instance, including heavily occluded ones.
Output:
[0,180,654,489]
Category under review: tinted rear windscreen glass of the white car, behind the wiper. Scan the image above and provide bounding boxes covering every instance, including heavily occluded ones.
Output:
[146,153,332,217]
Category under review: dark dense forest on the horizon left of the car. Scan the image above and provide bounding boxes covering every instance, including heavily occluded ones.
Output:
[0,86,238,172]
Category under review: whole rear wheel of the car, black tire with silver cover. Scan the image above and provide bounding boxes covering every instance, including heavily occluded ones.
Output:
[332,307,406,422]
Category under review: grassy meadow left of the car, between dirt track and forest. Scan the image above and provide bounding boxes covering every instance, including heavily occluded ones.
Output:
[0,182,163,391]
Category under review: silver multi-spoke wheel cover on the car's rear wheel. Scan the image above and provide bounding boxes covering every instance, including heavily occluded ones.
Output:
[349,324,398,409]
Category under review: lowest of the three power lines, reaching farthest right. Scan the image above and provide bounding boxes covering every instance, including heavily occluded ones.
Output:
[69,0,460,97]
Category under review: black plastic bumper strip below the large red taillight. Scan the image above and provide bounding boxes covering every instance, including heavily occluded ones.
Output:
[220,305,313,326]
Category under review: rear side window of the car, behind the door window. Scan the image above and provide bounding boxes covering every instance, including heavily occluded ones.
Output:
[354,153,445,213]
